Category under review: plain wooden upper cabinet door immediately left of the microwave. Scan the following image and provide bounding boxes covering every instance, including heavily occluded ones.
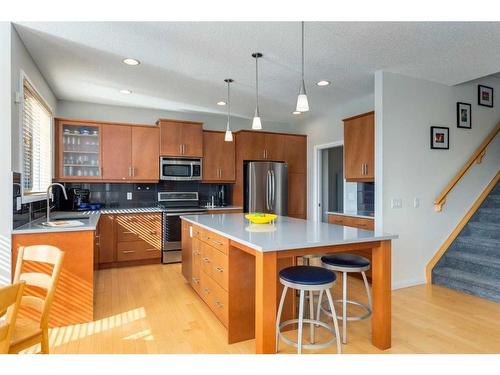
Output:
[132,126,160,181]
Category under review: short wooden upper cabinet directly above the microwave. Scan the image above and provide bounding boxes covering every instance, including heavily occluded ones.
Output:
[158,120,203,157]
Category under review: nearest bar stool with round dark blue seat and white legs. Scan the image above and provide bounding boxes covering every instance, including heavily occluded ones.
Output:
[276,266,342,354]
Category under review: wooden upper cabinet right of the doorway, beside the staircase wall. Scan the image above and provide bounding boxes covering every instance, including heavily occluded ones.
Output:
[343,112,375,182]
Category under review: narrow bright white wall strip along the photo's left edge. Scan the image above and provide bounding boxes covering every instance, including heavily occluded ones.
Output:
[0,22,12,285]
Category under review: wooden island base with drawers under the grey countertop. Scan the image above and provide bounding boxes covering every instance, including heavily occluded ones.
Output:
[182,221,296,344]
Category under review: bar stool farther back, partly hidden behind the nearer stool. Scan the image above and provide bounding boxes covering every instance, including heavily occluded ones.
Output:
[316,254,372,344]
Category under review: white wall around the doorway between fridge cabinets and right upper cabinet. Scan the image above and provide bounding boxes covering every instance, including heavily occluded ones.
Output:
[303,95,374,220]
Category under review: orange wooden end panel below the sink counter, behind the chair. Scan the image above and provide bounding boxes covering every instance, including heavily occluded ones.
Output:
[12,231,95,327]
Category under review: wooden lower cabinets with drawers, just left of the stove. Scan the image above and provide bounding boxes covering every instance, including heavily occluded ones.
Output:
[99,213,161,268]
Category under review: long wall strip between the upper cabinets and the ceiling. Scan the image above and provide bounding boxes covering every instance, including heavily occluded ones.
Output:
[57,100,300,133]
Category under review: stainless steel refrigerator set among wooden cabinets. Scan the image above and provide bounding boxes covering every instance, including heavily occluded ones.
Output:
[243,161,288,216]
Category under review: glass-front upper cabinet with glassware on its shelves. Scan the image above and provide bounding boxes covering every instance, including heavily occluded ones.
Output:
[56,120,102,181]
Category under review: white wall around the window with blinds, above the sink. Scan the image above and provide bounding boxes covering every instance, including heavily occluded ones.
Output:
[10,27,57,172]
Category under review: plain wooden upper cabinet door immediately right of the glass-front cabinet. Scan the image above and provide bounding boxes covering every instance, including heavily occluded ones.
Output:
[102,125,132,180]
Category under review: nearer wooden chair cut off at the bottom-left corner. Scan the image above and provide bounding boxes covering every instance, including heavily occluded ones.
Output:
[0,281,24,354]
